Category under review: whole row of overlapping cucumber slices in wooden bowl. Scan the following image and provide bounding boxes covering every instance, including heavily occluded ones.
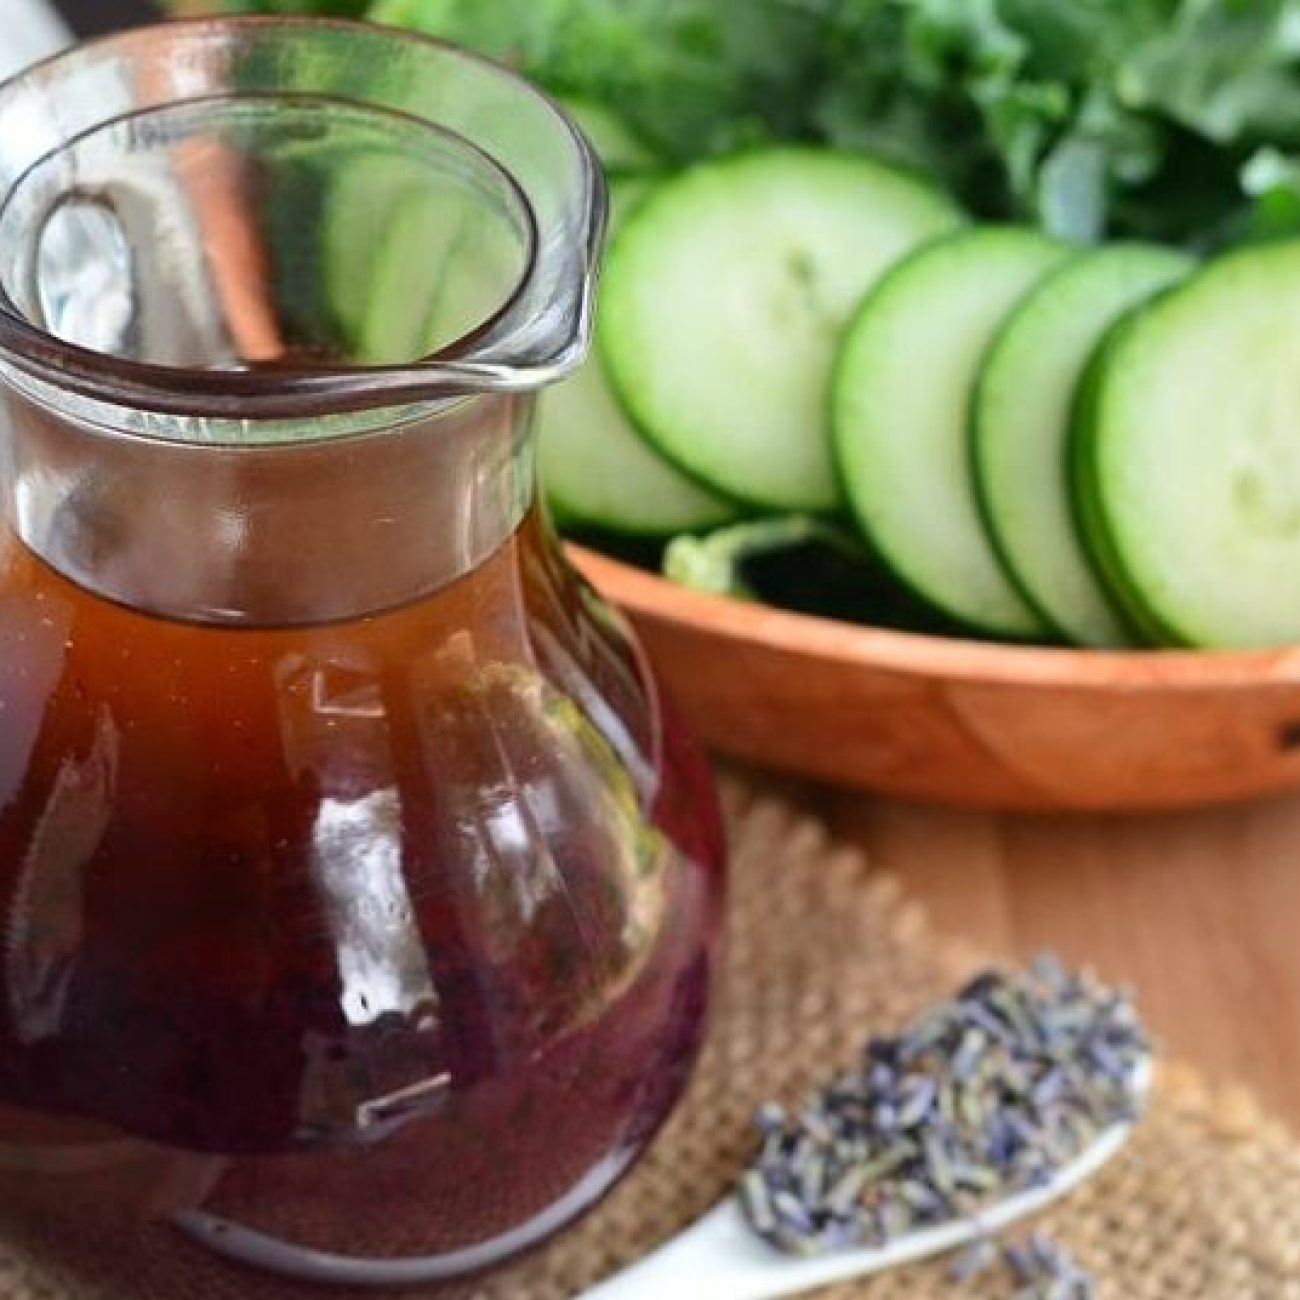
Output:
[410,105,1300,649]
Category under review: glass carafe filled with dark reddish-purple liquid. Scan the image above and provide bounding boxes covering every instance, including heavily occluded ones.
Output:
[0,20,723,1300]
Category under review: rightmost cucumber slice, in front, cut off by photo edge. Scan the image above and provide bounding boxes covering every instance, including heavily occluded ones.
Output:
[1075,241,1300,649]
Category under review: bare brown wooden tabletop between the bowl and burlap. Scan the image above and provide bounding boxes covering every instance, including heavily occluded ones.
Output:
[794,787,1300,1132]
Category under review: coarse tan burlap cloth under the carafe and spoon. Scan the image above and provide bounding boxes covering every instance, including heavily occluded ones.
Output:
[0,784,1300,1300]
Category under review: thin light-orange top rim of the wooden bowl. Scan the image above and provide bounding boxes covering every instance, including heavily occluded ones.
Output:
[568,543,1300,692]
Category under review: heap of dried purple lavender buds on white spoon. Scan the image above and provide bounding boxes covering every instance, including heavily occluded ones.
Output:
[740,957,1151,1256]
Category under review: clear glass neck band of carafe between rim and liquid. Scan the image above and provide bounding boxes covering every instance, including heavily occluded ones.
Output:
[0,386,534,627]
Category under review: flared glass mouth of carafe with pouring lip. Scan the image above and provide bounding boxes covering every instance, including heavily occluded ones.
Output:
[0,20,606,418]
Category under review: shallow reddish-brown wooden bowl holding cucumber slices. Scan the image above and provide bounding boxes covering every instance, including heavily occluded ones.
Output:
[571,547,1300,811]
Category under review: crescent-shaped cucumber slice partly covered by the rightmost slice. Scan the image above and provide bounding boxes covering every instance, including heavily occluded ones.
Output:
[972,244,1196,646]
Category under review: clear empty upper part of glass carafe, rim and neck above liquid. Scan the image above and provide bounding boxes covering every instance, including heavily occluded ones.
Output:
[0,20,605,624]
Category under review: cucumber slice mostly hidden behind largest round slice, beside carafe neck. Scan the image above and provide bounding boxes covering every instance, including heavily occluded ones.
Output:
[538,181,740,537]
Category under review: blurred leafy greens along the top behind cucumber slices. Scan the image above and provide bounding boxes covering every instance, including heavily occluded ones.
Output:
[215,0,1300,246]
